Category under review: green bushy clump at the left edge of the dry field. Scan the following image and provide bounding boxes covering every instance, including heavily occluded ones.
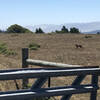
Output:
[0,43,16,56]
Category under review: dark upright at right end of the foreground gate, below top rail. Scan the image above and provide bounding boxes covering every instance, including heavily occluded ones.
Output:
[90,74,98,100]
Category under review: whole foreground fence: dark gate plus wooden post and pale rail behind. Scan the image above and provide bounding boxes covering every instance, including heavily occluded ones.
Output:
[0,49,100,100]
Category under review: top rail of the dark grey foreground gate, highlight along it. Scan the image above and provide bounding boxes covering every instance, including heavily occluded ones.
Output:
[0,68,100,80]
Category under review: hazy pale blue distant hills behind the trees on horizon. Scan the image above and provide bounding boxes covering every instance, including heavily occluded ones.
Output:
[26,22,100,33]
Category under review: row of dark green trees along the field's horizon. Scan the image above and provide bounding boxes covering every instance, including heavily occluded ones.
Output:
[0,24,80,34]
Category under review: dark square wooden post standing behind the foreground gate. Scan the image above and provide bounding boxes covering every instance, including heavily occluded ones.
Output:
[22,48,28,89]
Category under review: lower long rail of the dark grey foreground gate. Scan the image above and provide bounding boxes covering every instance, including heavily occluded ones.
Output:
[0,85,98,100]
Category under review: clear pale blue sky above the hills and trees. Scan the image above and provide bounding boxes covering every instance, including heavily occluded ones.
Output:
[0,0,100,28]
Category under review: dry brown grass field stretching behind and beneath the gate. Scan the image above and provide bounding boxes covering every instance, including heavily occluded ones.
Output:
[0,34,100,100]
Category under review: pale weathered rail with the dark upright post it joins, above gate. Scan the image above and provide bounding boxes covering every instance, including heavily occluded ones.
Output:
[22,48,82,68]
